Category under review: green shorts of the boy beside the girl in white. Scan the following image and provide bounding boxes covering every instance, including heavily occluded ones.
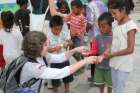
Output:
[94,67,112,87]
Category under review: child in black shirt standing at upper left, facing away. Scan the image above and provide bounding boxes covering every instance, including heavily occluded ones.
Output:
[15,0,30,36]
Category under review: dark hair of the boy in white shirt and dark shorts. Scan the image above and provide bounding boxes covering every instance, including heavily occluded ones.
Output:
[49,15,63,28]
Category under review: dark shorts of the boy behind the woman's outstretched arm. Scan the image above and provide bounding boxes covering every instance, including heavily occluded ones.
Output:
[51,60,73,87]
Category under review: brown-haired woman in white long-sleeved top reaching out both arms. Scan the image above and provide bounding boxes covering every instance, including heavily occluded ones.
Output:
[20,31,96,93]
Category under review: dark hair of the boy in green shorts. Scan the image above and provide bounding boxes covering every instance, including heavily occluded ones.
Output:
[98,12,114,26]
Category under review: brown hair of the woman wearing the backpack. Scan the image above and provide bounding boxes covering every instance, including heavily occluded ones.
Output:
[22,31,47,59]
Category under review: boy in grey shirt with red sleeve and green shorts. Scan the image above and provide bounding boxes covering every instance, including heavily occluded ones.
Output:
[83,12,113,93]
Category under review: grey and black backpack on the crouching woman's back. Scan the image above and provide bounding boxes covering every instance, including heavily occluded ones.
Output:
[0,56,42,93]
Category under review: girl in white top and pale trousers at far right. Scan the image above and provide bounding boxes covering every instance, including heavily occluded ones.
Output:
[106,0,138,93]
